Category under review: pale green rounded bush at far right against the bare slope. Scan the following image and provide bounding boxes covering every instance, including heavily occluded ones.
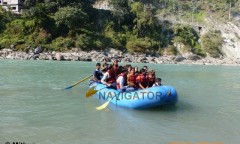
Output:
[202,30,223,58]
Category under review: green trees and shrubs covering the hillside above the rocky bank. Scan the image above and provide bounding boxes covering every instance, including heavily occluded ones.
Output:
[0,0,239,57]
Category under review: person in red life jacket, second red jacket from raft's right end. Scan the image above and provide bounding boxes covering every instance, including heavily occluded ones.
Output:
[136,69,148,89]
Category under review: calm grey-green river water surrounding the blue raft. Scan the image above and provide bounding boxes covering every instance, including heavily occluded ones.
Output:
[0,60,240,144]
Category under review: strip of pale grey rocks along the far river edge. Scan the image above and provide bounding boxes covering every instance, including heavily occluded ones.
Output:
[0,48,240,66]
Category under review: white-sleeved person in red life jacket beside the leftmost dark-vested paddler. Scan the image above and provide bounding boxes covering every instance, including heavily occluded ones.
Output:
[101,65,116,88]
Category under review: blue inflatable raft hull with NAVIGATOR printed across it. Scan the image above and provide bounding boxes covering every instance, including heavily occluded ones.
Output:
[89,83,178,109]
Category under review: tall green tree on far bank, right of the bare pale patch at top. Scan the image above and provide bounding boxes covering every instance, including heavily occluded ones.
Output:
[128,2,163,53]
